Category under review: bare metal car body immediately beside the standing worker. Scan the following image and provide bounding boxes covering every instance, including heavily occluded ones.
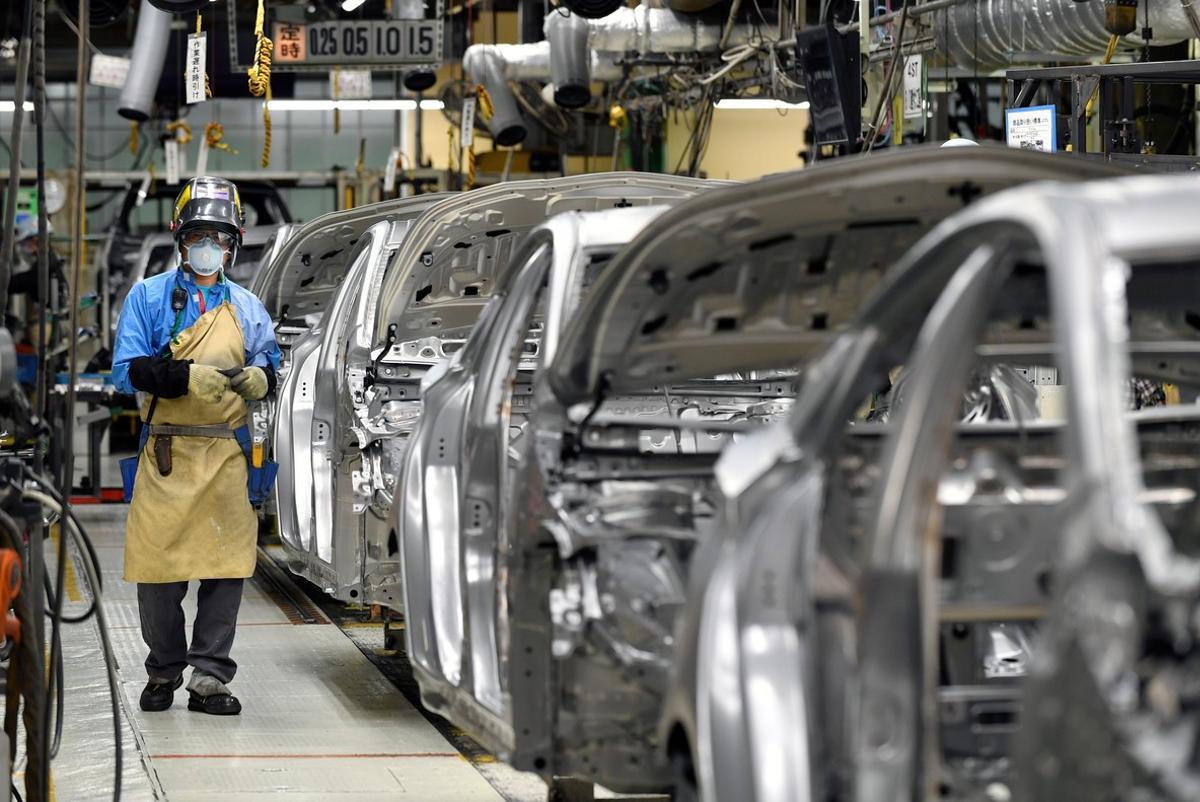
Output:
[276,173,707,600]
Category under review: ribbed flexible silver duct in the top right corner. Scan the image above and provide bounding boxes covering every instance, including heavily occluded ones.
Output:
[929,0,1195,67]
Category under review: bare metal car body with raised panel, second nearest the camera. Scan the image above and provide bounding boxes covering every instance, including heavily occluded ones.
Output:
[396,145,1132,791]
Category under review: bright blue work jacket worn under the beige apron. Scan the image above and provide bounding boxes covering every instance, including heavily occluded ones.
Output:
[113,269,280,394]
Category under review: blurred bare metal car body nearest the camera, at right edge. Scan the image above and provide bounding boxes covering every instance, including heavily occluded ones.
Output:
[665,172,1200,802]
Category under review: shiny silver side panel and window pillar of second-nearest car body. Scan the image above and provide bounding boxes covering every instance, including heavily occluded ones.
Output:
[395,201,691,754]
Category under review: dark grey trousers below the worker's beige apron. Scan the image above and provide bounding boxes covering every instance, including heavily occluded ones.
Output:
[138,579,246,682]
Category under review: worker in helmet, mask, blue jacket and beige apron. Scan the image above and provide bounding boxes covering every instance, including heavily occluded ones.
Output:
[113,176,280,716]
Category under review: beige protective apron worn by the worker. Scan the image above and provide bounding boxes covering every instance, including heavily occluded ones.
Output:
[125,301,258,582]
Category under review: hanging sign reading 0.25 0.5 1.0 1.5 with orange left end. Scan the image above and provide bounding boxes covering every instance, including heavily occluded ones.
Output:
[272,19,442,65]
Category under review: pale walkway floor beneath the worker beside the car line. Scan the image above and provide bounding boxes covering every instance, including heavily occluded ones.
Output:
[47,504,506,802]
